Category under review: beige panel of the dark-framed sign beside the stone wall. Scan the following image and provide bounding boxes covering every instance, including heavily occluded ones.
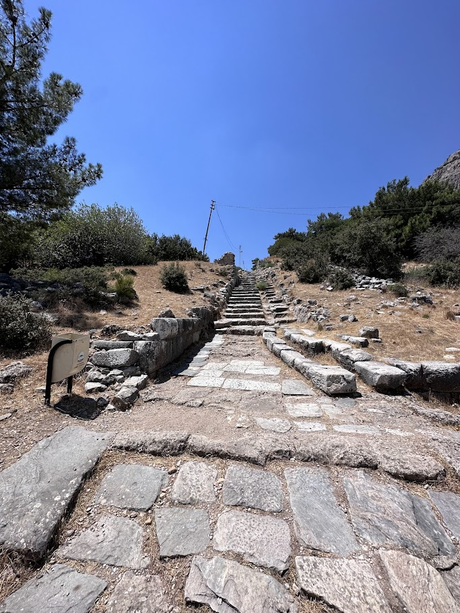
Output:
[51,332,89,383]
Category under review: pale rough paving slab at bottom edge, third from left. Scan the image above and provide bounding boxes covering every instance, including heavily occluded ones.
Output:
[185,557,298,613]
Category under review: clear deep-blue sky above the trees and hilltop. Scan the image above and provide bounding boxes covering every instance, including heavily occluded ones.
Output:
[24,0,460,268]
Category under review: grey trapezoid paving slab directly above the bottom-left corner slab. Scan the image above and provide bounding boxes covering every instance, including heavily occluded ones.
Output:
[58,515,149,569]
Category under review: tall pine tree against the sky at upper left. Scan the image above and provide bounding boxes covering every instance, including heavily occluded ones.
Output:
[0,0,102,219]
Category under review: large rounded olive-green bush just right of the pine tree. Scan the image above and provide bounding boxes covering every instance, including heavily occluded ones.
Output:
[35,204,147,268]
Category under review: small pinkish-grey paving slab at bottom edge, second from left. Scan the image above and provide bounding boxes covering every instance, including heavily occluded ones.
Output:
[106,570,174,613]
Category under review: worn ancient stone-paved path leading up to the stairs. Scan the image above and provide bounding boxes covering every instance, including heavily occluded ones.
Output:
[0,336,460,613]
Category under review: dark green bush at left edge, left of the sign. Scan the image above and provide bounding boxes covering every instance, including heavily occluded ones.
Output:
[0,294,51,355]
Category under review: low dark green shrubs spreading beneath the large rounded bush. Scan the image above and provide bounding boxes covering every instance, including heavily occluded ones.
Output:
[11,267,108,307]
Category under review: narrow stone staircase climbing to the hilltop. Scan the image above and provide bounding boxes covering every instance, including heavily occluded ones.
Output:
[214,273,268,335]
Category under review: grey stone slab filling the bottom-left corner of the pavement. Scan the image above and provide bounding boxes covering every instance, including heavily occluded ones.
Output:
[0,564,107,613]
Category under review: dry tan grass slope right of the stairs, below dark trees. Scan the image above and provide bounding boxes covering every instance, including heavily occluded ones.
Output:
[277,271,460,362]
